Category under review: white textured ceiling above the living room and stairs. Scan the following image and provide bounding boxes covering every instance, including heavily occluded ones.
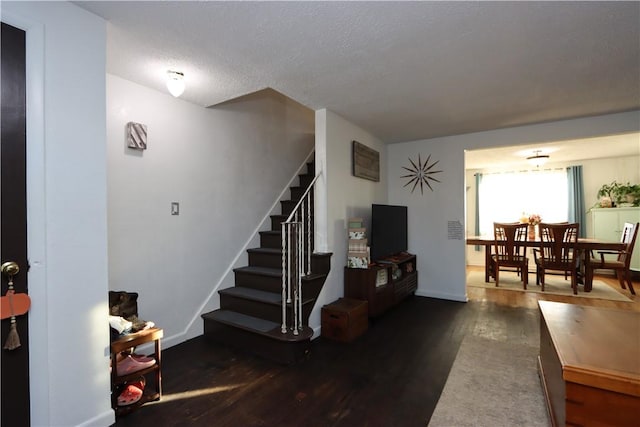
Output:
[74,1,640,143]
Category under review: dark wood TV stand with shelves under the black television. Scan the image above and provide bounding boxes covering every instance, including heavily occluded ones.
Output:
[344,253,418,317]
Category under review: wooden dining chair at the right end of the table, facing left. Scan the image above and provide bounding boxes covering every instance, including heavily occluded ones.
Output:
[586,222,640,295]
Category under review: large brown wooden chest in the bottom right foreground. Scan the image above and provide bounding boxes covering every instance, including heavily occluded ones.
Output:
[538,301,640,426]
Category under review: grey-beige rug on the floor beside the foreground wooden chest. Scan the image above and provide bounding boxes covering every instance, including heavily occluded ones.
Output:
[429,334,550,427]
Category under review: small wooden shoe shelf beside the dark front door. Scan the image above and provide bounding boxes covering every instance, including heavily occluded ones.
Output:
[111,328,164,417]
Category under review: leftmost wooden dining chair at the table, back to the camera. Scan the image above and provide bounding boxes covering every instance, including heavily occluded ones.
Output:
[491,222,529,289]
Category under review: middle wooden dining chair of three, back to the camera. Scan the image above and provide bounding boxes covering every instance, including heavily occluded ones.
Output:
[534,222,580,294]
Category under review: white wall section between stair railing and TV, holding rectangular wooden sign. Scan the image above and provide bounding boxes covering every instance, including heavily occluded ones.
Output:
[309,109,387,334]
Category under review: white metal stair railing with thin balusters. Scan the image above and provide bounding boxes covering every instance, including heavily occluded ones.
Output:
[282,175,319,335]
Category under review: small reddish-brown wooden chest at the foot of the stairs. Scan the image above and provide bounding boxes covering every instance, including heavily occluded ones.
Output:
[321,298,369,342]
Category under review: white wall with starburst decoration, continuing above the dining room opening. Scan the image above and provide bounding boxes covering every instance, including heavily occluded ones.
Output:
[387,111,640,301]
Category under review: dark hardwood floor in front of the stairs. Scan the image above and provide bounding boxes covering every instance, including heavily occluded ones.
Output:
[114,297,484,427]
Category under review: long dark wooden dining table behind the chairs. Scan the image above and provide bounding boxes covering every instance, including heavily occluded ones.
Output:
[467,236,625,292]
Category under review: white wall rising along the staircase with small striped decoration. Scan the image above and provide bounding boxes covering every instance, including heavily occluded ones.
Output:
[107,74,314,348]
